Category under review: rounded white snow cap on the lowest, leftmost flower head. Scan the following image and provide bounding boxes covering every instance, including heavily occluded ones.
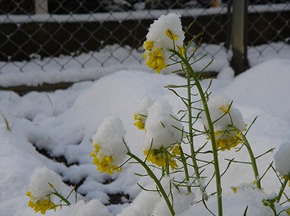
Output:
[29,167,65,200]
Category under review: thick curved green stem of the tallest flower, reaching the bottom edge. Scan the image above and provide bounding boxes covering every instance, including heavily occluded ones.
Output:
[177,53,223,216]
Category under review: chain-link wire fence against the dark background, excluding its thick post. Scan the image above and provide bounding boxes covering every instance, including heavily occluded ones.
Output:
[0,0,290,77]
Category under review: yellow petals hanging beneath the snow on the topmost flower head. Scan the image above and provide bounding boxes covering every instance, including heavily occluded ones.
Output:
[143,47,167,73]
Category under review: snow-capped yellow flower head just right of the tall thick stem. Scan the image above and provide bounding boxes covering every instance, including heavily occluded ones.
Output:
[201,96,246,151]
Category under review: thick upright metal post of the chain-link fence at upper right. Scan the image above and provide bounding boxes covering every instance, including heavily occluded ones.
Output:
[231,0,248,75]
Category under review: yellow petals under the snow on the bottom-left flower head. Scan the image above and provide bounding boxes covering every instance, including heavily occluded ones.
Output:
[26,191,56,214]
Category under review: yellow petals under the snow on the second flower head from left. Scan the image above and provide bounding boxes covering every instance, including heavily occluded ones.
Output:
[90,143,122,175]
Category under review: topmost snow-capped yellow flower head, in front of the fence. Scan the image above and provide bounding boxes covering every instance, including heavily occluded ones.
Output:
[143,13,184,73]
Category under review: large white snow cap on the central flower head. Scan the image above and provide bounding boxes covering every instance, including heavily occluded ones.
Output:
[145,100,182,149]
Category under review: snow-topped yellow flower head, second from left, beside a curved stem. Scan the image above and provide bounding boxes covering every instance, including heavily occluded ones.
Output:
[90,116,127,175]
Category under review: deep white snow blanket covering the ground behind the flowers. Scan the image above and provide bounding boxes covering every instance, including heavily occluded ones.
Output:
[0,53,290,216]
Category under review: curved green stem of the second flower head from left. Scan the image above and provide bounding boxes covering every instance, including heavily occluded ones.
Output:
[127,151,175,216]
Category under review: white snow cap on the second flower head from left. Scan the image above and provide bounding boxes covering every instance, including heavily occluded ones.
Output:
[92,116,127,165]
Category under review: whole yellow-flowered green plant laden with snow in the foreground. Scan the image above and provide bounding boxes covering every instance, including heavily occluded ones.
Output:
[27,13,290,216]
